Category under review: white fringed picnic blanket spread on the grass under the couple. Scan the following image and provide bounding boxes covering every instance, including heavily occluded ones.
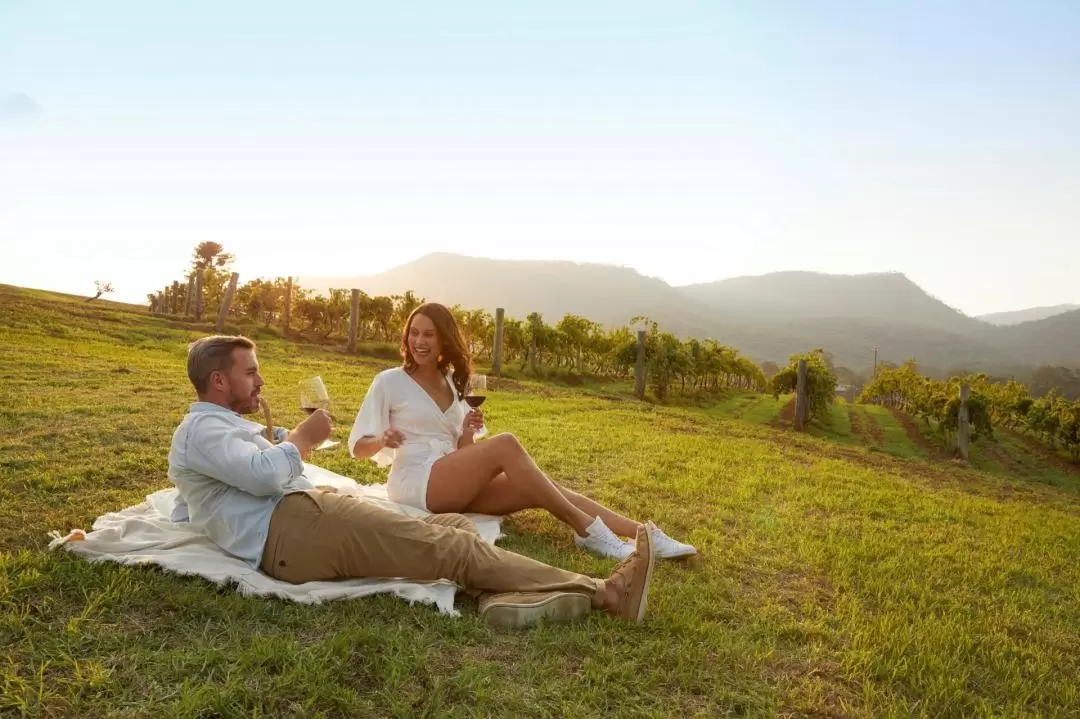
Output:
[49,464,502,616]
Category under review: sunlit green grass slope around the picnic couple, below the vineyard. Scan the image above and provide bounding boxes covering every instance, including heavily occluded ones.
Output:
[0,287,1080,718]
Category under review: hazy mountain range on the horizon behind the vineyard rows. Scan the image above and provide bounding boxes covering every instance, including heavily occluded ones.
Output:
[300,254,1080,375]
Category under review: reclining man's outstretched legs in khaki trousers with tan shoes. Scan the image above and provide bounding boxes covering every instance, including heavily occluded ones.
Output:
[262,492,654,626]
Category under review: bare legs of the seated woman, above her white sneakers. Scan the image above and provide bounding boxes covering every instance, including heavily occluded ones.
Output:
[427,427,593,537]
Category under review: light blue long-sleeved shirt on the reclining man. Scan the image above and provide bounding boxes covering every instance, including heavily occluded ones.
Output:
[168,402,312,569]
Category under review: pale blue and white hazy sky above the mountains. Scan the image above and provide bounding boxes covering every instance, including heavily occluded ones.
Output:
[0,0,1080,313]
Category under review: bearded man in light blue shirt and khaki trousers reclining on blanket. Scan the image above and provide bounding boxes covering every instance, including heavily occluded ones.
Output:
[168,336,653,626]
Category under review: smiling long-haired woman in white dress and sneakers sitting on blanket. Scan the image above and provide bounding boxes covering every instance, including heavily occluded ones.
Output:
[349,302,697,559]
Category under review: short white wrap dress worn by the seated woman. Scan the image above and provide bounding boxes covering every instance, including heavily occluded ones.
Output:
[349,367,469,510]
